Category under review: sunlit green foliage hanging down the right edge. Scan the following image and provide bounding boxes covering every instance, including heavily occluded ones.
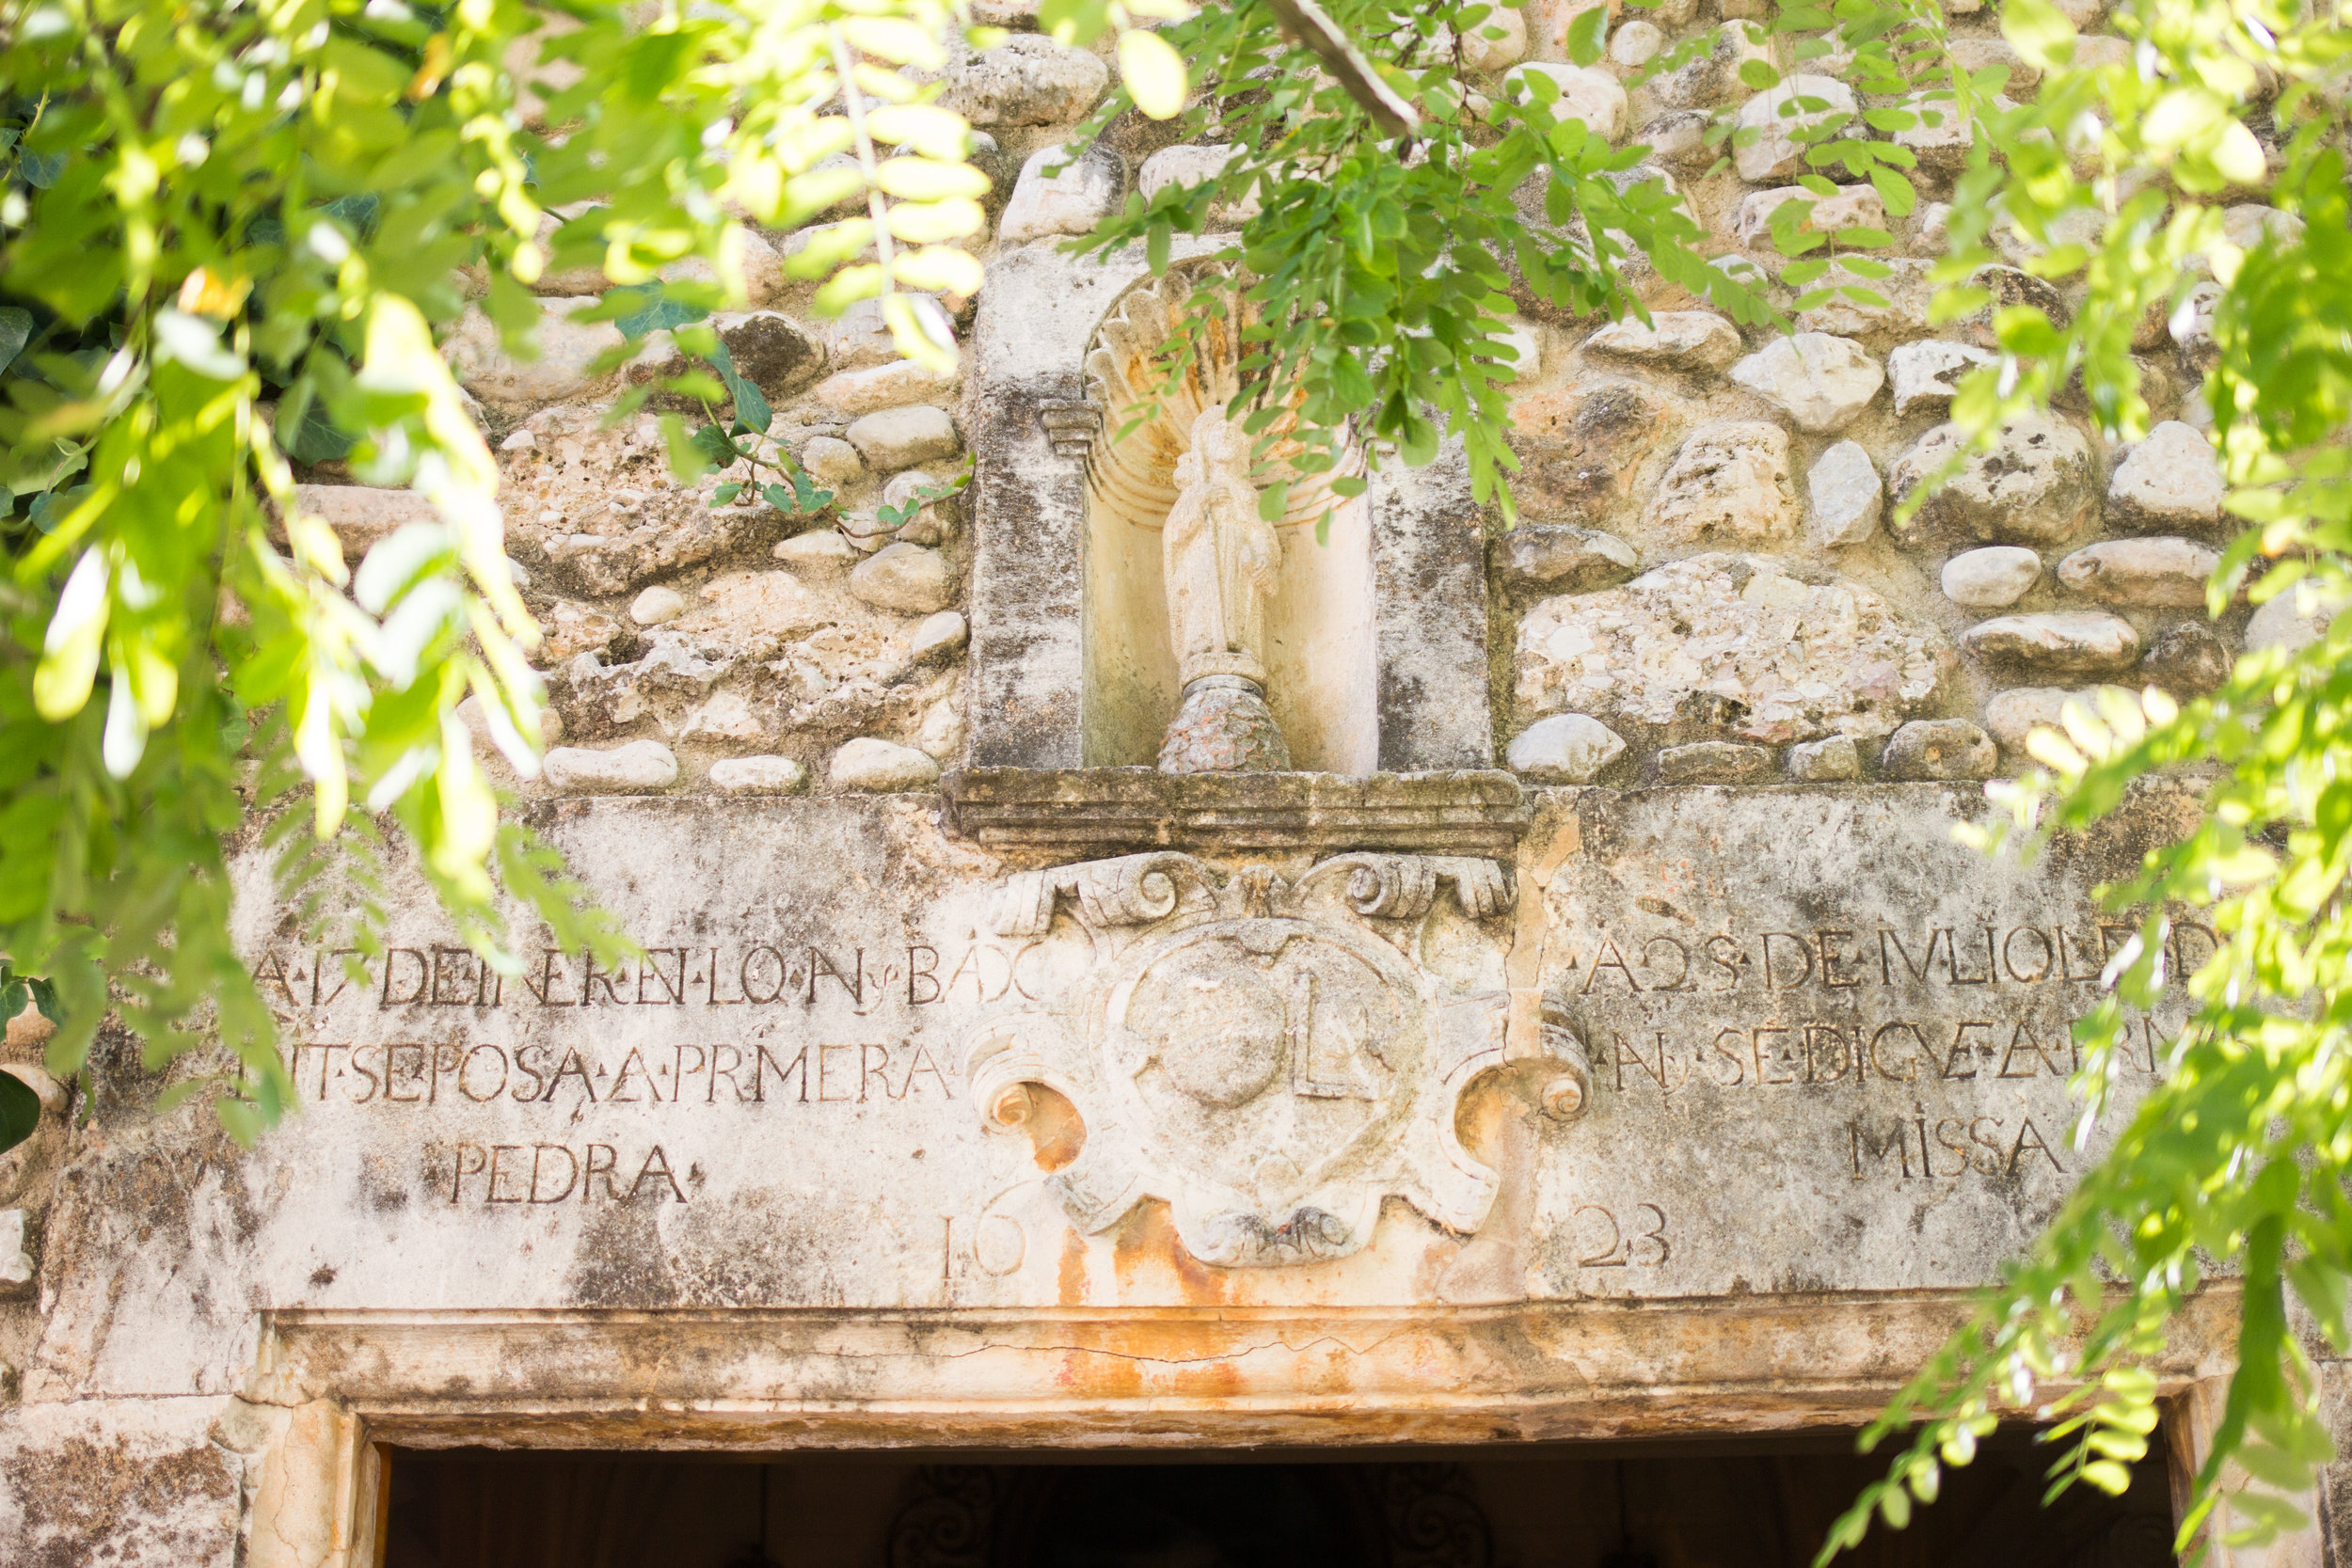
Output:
[1823,0,2352,1561]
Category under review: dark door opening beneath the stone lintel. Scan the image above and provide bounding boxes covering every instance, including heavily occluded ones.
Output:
[384,1432,2173,1568]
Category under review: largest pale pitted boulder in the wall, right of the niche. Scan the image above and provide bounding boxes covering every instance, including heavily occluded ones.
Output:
[1518,555,1950,743]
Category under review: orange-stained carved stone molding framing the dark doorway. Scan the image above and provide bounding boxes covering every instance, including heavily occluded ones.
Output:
[224,1281,2239,1568]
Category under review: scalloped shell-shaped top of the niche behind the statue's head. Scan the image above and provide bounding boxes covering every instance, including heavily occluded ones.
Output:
[1087,263,1364,540]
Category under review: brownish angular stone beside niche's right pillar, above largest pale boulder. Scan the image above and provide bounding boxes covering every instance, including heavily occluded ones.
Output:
[1510,376,1692,522]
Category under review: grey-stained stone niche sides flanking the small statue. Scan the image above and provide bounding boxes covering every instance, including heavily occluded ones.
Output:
[969,242,1494,776]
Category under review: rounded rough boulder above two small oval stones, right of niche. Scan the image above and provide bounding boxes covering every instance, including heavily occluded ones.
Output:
[1886,414,2098,543]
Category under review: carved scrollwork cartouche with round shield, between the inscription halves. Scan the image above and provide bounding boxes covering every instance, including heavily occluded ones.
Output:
[964,853,1590,1267]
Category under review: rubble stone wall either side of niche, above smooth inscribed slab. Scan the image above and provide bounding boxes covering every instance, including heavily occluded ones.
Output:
[257,0,2305,795]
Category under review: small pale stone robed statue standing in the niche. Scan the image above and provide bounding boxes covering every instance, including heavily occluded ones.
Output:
[1160,409,1292,773]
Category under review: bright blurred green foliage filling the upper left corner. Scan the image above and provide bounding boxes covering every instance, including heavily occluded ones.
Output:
[0,0,1165,1135]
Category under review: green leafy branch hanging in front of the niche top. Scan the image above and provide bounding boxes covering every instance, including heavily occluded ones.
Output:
[1077,0,1772,517]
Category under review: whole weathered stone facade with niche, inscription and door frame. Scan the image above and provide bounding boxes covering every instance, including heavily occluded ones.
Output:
[0,0,2341,1568]
